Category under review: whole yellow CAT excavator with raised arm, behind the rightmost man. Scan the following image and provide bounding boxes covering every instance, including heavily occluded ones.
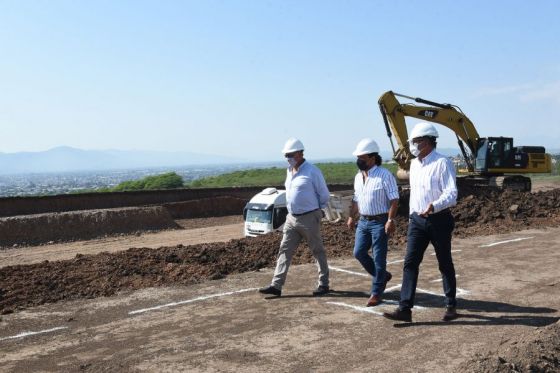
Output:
[379,91,552,191]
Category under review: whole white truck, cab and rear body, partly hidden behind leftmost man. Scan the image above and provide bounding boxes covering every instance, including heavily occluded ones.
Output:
[243,188,352,237]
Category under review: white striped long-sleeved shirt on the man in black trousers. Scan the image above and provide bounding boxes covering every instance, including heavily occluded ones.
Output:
[410,150,457,214]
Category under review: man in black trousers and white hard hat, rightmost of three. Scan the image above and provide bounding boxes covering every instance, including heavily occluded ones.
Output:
[383,123,457,322]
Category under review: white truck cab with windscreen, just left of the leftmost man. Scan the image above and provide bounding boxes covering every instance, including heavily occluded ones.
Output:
[243,188,288,237]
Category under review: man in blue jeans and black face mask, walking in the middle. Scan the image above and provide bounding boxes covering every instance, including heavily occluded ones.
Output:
[347,138,399,307]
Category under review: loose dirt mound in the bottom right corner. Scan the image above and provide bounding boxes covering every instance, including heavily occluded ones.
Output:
[457,321,560,373]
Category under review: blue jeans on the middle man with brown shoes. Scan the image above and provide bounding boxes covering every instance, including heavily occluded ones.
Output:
[354,217,387,295]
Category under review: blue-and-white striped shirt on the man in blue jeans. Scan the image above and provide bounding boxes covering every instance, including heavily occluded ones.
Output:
[353,166,399,215]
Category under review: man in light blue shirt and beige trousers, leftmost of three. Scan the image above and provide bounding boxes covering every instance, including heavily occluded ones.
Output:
[259,138,330,296]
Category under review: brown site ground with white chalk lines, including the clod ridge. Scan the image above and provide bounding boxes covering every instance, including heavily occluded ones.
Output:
[0,179,560,372]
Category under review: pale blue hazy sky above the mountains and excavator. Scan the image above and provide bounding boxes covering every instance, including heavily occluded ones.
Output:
[0,0,560,160]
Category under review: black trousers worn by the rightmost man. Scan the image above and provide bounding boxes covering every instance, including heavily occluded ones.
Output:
[399,210,457,310]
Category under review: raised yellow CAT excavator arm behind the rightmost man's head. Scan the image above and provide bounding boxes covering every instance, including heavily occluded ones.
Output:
[379,91,480,179]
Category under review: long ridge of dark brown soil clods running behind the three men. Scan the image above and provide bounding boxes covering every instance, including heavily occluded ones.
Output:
[0,189,560,313]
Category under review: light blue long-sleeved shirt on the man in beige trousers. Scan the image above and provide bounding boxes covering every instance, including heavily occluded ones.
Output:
[284,161,330,214]
